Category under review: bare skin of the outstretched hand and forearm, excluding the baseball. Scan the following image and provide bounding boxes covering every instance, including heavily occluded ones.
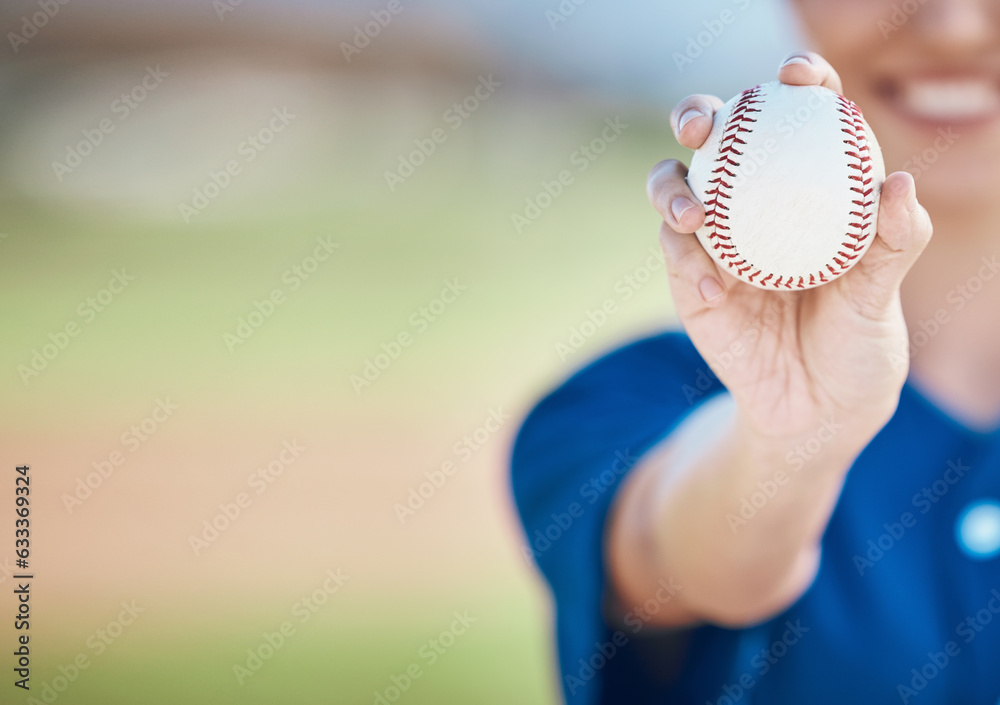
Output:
[606,52,932,626]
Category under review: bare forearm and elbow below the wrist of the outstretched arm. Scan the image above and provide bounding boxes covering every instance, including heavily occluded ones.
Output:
[608,394,878,625]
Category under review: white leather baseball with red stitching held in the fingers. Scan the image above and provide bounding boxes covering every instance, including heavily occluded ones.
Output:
[687,82,885,290]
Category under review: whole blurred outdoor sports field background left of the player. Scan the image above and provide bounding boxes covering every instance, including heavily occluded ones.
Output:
[0,0,798,705]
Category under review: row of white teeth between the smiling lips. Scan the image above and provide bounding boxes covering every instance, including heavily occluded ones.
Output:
[902,79,1000,121]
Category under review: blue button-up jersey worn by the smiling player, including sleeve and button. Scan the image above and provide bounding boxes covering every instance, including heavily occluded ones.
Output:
[512,333,1000,705]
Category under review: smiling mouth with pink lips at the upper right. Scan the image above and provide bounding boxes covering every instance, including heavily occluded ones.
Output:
[879,75,1000,126]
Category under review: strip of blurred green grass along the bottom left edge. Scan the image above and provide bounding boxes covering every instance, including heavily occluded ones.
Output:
[23,596,551,705]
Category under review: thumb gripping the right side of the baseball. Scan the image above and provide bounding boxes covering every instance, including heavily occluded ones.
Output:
[841,171,933,312]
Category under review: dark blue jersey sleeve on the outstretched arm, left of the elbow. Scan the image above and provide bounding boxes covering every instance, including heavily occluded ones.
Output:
[511,333,723,705]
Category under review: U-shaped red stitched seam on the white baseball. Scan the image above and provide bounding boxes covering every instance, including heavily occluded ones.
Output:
[705,85,875,289]
